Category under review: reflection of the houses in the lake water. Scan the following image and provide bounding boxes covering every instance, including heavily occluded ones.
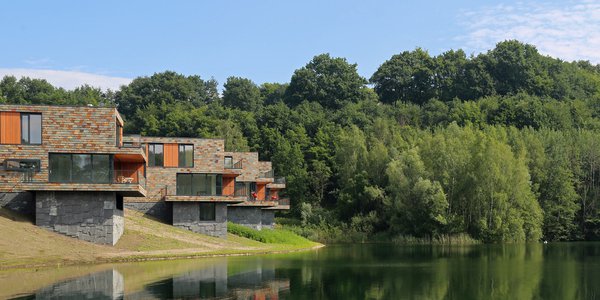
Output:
[10,260,290,299]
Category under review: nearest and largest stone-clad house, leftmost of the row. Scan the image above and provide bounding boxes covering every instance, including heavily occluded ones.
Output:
[0,105,146,245]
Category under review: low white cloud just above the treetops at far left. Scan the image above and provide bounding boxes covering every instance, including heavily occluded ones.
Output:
[0,68,131,90]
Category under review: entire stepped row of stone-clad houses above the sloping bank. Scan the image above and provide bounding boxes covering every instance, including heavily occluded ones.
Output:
[0,105,289,245]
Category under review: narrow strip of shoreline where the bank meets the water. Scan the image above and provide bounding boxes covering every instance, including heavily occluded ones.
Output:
[0,243,326,272]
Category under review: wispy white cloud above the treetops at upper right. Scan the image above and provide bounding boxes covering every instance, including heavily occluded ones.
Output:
[458,0,600,63]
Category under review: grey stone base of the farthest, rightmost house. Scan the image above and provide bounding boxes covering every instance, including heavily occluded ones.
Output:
[227,206,275,230]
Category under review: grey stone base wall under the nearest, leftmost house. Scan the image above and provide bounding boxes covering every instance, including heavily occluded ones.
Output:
[35,192,125,245]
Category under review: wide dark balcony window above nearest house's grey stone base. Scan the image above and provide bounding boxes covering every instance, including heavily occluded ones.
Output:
[48,153,113,183]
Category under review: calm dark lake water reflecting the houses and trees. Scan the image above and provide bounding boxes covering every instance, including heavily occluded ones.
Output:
[0,243,600,299]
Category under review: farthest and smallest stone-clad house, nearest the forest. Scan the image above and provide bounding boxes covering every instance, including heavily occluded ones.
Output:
[225,152,290,230]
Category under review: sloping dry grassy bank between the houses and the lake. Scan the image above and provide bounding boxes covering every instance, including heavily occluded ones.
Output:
[0,209,322,269]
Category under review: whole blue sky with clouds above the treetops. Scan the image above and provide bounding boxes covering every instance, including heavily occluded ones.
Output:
[0,0,600,89]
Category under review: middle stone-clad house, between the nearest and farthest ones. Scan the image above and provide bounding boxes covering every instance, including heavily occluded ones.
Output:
[125,136,246,237]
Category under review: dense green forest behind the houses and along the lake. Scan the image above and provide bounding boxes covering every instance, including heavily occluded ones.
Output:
[0,41,600,242]
